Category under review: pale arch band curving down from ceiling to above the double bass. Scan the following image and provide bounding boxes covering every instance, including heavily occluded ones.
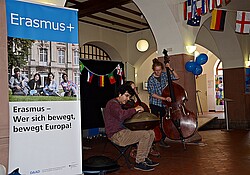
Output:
[134,0,184,54]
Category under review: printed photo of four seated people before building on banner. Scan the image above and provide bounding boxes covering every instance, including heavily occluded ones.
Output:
[8,37,80,101]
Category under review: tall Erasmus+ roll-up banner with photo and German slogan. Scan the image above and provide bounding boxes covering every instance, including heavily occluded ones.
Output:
[6,0,82,175]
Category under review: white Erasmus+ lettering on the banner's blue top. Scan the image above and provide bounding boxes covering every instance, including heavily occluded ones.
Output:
[10,13,75,32]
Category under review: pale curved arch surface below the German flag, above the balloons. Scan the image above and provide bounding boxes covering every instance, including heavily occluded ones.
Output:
[195,17,244,68]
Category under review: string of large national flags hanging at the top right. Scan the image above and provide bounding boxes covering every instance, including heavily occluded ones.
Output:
[183,0,250,34]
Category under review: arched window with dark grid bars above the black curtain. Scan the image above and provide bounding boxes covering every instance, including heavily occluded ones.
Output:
[81,44,111,60]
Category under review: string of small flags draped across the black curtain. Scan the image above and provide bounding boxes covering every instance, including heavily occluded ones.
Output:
[79,61,123,87]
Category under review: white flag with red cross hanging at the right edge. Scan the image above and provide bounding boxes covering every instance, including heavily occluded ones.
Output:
[235,11,250,33]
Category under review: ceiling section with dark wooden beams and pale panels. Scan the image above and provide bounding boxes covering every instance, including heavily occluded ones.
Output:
[65,0,149,33]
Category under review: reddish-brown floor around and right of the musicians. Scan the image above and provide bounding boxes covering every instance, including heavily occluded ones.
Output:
[83,130,250,175]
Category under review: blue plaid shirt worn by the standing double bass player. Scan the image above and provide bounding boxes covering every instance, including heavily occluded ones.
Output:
[148,72,176,107]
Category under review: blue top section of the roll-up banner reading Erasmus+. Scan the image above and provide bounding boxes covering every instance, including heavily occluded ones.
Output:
[6,0,78,43]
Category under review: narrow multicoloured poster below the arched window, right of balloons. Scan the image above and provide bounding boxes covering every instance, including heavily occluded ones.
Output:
[215,75,224,111]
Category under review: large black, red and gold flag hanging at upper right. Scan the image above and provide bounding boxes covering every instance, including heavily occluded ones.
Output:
[210,9,226,31]
